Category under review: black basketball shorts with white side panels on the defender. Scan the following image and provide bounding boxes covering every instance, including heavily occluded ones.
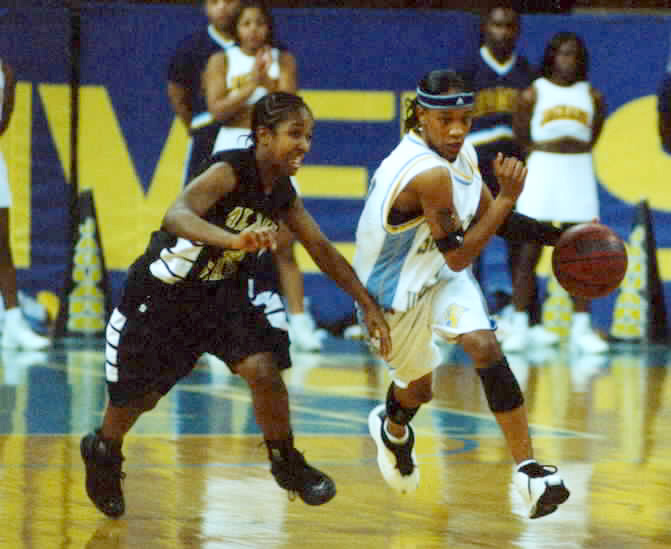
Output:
[105,282,291,406]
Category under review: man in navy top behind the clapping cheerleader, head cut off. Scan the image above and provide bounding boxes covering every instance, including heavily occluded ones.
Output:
[168,0,240,185]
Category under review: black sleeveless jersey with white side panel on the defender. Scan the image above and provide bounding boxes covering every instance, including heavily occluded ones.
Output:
[128,148,296,306]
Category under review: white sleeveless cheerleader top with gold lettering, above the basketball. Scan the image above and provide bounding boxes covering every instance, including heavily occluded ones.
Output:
[530,78,594,143]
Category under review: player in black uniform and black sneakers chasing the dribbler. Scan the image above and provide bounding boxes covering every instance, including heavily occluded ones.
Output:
[81,92,391,517]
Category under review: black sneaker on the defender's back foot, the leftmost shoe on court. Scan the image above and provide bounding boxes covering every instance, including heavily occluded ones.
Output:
[80,430,126,518]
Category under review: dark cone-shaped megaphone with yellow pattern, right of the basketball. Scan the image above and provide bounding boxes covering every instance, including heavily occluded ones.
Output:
[610,200,669,343]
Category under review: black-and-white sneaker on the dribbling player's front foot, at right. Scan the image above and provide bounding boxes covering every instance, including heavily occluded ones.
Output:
[513,461,570,518]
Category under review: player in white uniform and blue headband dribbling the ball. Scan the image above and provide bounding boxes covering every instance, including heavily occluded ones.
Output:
[354,70,569,518]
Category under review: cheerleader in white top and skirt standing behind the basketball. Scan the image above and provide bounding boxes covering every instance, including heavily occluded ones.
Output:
[510,32,608,353]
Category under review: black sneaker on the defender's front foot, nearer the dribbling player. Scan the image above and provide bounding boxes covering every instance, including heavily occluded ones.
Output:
[270,448,335,505]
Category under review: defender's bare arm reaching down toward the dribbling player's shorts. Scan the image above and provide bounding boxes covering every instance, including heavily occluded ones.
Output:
[286,197,391,357]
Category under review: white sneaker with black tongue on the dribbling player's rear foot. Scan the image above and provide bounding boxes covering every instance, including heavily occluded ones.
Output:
[368,404,419,494]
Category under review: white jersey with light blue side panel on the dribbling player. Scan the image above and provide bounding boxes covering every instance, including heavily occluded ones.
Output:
[353,132,482,311]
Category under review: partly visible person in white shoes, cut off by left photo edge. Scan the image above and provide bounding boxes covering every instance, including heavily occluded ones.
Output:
[0,59,50,350]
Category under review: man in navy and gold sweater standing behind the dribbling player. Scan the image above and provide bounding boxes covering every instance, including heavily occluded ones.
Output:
[466,4,559,352]
